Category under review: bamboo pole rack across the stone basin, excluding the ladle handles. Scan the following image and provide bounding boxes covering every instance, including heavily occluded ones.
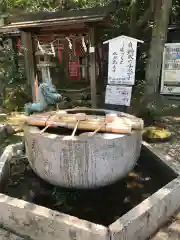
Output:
[25,110,144,134]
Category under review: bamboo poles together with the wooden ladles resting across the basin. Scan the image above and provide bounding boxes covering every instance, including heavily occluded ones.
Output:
[25,111,135,136]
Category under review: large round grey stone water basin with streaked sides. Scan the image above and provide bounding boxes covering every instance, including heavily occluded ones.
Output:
[24,109,142,188]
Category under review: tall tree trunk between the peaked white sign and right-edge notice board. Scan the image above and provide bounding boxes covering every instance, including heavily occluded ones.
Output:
[143,0,172,106]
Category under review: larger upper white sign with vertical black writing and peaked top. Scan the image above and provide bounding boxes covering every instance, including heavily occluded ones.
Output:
[108,36,138,85]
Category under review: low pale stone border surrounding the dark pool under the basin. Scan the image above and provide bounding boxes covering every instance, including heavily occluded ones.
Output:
[0,143,180,240]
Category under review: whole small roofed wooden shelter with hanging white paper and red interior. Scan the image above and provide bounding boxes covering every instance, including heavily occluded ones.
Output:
[0,3,115,108]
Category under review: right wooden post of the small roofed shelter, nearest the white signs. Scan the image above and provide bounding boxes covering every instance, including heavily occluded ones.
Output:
[89,28,97,108]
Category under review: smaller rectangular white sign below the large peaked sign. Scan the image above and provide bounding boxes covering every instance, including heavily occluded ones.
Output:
[105,85,132,106]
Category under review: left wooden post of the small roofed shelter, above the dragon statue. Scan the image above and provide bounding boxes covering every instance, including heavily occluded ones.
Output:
[21,32,37,102]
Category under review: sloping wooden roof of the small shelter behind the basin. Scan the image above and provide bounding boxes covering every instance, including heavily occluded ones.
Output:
[0,4,115,31]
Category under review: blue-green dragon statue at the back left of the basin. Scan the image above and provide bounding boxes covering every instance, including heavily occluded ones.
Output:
[24,82,62,115]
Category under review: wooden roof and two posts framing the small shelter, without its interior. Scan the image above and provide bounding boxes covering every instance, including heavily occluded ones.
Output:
[0,3,116,108]
